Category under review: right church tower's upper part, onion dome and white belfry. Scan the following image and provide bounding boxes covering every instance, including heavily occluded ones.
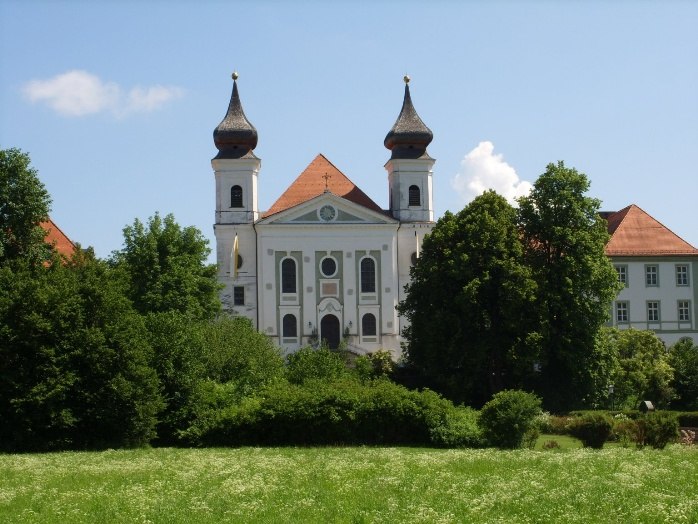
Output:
[383,75,435,222]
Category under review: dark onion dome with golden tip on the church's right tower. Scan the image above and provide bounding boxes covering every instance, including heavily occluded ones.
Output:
[383,76,434,158]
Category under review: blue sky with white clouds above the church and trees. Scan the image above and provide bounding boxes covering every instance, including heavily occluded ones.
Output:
[0,0,698,257]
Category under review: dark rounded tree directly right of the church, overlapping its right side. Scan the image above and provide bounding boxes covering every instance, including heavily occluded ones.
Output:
[399,191,535,405]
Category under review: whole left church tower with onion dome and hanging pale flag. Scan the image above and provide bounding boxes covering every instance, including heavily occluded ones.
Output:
[211,72,261,327]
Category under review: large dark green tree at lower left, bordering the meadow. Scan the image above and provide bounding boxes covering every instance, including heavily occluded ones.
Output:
[0,251,162,450]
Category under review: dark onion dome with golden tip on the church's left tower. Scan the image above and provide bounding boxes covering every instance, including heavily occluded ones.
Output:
[213,73,257,158]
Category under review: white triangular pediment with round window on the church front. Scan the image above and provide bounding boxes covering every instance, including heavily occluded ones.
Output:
[257,192,397,225]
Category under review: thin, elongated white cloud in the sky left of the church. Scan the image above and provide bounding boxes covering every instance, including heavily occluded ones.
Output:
[22,70,184,117]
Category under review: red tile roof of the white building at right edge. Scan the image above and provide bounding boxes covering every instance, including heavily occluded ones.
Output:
[602,204,698,256]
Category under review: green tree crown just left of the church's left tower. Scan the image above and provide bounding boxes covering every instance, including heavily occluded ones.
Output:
[112,213,220,319]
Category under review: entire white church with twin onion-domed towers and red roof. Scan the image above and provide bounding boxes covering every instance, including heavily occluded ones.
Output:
[211,74,435,357]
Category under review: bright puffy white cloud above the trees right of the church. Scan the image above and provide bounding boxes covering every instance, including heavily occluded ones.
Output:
[451,141,532,204]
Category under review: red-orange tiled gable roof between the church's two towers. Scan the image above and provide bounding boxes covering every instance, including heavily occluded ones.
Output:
[263,154,383,218]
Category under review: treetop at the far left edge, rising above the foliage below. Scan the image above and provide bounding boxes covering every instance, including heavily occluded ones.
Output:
[0,149,51,264]
